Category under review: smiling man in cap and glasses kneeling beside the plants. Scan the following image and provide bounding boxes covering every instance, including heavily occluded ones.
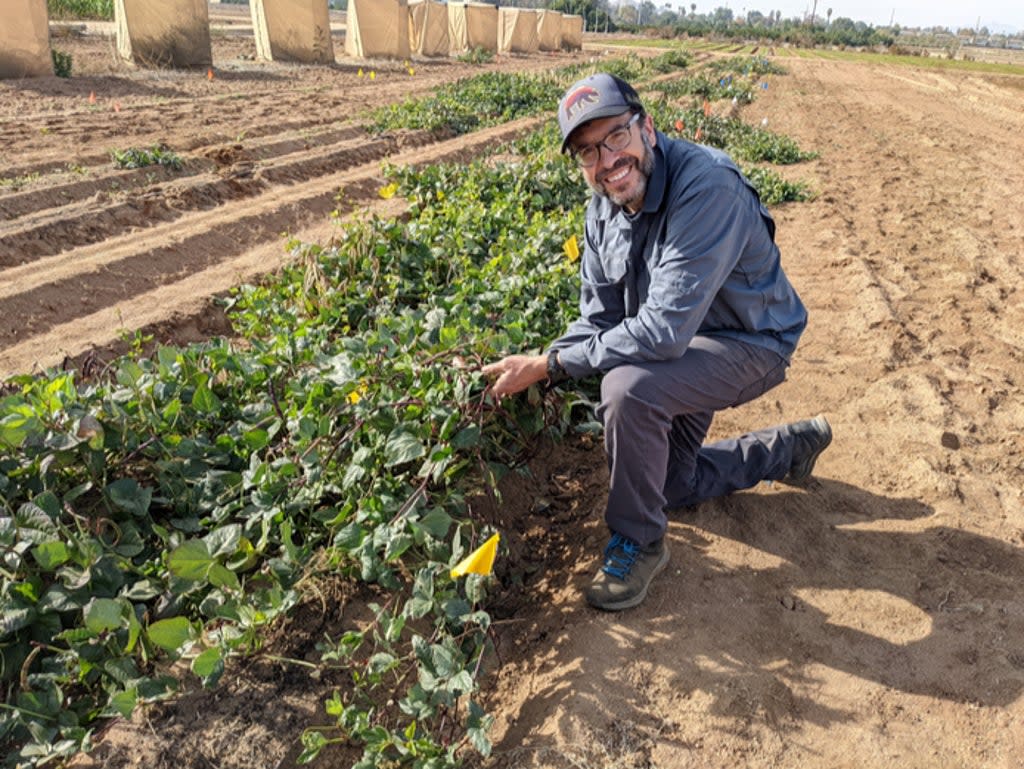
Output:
[483,74,831,611]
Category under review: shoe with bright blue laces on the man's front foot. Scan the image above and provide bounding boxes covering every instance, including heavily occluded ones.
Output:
[586,533,669,611]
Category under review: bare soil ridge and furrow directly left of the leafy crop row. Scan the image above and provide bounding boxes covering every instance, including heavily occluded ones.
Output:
[0,118,545,375]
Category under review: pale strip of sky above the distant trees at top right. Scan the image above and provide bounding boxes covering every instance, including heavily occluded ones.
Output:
[712,0,1024,33]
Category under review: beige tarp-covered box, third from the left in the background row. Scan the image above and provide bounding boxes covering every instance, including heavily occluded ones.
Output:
[249,0,334,65]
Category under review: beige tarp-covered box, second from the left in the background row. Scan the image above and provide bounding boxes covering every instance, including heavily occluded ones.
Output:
[114,0,213,69]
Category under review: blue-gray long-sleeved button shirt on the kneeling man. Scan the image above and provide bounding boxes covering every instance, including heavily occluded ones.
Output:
[551,132,807,378]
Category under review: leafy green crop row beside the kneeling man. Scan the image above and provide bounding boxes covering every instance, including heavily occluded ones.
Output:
[0,53,815,769]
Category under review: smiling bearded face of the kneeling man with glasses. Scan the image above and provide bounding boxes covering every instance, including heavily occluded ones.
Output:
[570,112,656,212]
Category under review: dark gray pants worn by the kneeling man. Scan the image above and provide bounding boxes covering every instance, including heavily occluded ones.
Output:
[598,336,793,545]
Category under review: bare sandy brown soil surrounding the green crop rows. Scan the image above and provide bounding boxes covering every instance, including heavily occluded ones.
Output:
[0,16,1024,769]
